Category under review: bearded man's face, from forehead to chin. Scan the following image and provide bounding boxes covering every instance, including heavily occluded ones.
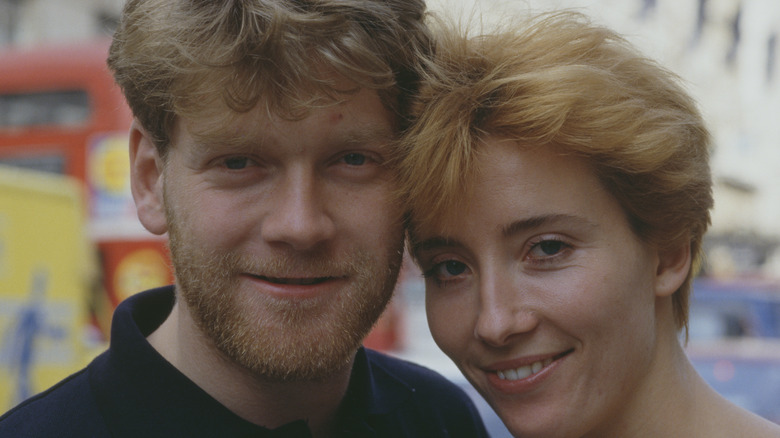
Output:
[156,90,403,381]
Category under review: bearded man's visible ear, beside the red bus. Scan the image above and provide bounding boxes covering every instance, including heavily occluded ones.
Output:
[130,120,168,235]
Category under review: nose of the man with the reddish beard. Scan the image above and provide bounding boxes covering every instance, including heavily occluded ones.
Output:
[262,169,336,251]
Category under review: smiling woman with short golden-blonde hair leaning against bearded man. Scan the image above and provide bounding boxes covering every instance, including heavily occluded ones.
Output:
[402,13,780,438]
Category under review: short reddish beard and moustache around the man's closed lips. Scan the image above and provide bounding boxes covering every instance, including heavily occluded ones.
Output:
[168,221,401,381]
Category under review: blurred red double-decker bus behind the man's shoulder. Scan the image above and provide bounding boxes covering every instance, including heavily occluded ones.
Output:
[0,41,173,335]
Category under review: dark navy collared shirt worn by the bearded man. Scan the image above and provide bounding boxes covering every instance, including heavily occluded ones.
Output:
[0,286,487,438]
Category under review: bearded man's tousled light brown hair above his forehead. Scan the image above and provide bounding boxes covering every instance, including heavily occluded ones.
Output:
[108,0,430,152]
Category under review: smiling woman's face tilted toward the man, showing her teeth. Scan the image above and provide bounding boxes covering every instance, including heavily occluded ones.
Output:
[414,138,664,437]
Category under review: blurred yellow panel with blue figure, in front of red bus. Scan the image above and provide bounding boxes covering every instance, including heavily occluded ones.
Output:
[0,167,94,412]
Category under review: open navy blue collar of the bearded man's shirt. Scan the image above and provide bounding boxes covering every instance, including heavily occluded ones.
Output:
[90,286,413,437]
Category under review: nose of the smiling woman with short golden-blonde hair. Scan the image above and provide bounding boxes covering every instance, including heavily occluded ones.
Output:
[474,273,539,347]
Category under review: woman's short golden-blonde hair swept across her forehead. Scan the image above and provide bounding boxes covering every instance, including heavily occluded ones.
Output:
[400,11,713,329]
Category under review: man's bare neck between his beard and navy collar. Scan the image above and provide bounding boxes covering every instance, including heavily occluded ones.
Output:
[147,301,352,437]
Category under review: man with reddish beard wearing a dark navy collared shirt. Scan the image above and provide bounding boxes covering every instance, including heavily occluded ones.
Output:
[0,0,485,437]
